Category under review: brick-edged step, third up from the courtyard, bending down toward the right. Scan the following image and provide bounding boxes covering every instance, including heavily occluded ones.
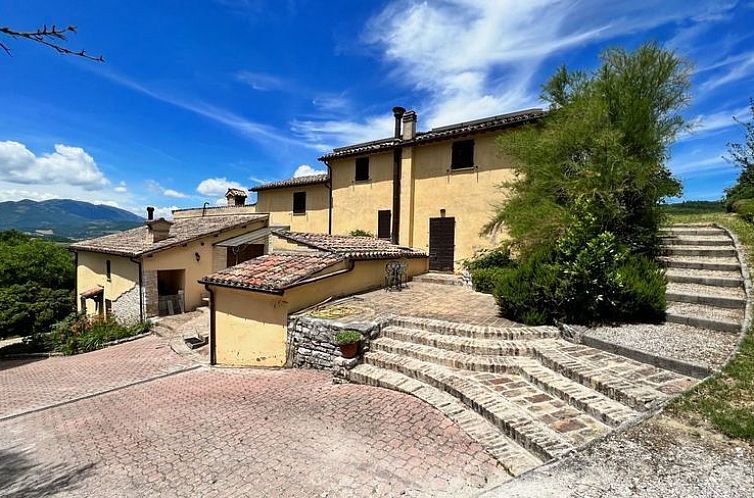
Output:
[372,337,636,426]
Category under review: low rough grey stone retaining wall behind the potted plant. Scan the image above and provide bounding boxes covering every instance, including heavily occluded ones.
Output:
[287,314,383,370]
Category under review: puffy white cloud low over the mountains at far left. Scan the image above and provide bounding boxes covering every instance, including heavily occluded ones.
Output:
[0,140,110,190]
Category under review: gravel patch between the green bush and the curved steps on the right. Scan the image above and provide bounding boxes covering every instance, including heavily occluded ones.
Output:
[584,323,738,367]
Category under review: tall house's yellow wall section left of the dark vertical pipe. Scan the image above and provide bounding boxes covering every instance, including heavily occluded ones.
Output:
[331,151,393,235]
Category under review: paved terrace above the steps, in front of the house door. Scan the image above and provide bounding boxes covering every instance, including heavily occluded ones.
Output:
[339,282,521,327]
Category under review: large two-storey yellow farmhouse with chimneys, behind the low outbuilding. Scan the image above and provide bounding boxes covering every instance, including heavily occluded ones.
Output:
[251,107,544,271]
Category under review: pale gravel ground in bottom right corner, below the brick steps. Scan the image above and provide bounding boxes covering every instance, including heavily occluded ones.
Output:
[481,416,754,498]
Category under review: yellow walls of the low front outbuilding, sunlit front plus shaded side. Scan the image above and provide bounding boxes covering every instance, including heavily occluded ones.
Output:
[213,258,428,366]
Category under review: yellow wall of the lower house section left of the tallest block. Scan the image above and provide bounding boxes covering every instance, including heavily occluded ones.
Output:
[256,184,330,233]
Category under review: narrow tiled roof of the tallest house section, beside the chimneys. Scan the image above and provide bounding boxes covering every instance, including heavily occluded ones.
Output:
[319,109,546,161]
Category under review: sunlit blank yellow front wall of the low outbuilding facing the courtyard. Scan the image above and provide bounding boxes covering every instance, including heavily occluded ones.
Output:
[213,287,288,367]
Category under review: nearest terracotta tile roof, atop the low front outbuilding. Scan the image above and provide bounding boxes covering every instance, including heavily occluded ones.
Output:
[201,251,346,294]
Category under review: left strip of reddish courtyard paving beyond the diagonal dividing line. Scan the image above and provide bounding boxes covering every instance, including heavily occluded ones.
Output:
[0,337,192,419]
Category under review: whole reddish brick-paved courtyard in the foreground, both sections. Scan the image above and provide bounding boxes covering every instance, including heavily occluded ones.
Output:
[0,337,505,497]
